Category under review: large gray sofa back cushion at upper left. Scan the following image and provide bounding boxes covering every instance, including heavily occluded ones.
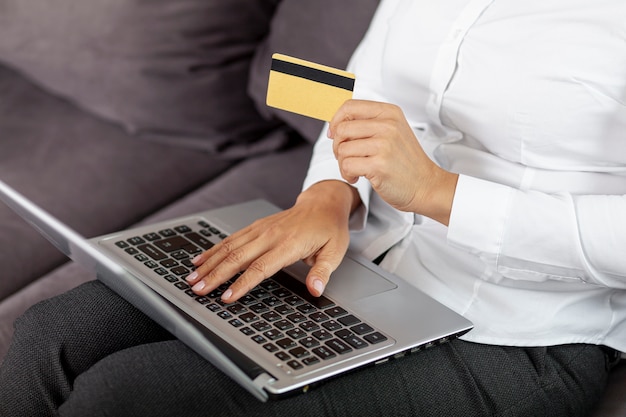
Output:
[0,0,285,157]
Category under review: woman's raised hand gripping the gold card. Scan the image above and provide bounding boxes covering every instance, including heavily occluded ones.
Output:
[328,100,458,225]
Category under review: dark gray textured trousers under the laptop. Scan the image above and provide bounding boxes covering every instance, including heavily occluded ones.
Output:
[0,281,610,417]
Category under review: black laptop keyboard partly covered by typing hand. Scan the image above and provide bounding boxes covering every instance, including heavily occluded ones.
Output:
[115,221,388,373]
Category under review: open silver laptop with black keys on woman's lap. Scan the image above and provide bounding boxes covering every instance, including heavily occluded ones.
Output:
[0,181,472,401]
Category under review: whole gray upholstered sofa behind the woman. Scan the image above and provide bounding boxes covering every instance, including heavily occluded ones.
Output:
[0,0,626,416]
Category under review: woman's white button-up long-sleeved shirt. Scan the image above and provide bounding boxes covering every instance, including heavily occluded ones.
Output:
[304,0,626,351]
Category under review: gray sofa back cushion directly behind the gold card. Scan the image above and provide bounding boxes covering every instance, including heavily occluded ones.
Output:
[249,0,379,141]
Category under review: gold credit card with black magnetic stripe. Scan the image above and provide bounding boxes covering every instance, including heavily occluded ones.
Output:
[267,54,355,122]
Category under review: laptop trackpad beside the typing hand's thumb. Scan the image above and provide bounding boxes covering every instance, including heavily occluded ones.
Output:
[324,257,398,301]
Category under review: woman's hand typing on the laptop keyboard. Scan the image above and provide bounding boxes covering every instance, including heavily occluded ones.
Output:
[187,181,360,302]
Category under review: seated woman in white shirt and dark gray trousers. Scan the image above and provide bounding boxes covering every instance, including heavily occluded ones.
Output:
[0,0,626,416]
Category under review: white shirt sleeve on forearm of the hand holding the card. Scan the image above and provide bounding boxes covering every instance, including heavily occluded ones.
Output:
[448,175,626,289]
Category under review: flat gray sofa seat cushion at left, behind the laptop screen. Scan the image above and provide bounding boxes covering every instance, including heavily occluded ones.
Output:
[0,67,237,300]
